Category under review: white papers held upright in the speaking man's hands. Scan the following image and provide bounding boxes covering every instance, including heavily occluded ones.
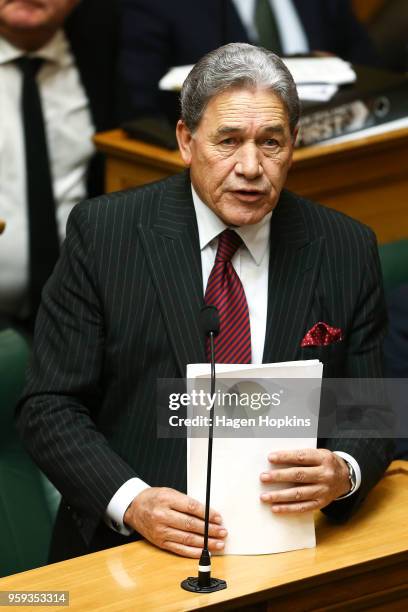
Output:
[187,360,323,555]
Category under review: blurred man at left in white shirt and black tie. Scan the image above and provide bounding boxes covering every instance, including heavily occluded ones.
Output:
[0,0,129,326]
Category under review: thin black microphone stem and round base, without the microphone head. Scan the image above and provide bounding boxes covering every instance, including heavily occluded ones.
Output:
[180,331,227,593]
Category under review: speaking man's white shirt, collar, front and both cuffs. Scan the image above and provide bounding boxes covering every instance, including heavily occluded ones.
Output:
[105,186,361,535]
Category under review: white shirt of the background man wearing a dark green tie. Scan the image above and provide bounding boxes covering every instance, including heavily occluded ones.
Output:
[233,0,310,55]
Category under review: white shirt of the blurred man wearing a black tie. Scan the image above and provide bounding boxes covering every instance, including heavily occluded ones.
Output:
[0,30,95,316]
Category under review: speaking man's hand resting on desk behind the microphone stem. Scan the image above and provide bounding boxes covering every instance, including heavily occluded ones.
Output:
[124,487,227,559]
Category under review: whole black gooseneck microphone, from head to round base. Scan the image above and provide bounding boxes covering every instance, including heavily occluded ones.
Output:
[181,306,227,593]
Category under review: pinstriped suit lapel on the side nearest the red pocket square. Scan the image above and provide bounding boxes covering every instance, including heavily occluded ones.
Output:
[263,192,323,363]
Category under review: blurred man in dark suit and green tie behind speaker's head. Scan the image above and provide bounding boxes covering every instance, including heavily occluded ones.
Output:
[122,0,376,118]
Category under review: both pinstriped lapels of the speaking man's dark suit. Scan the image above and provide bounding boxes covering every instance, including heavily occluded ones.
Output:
[138,174,324,376]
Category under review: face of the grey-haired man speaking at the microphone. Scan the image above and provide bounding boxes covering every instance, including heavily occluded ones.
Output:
[177,88,293,226]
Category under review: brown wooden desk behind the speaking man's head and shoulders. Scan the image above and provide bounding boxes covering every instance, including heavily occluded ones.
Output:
[95,128,408,243]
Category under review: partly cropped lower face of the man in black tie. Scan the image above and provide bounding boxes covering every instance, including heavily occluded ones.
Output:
[0,0,79,32]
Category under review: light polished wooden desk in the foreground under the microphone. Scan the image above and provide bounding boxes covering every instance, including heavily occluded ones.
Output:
[0,461,408,612]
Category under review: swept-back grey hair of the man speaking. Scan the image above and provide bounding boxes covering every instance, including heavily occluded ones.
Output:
[180,43,300,134]
